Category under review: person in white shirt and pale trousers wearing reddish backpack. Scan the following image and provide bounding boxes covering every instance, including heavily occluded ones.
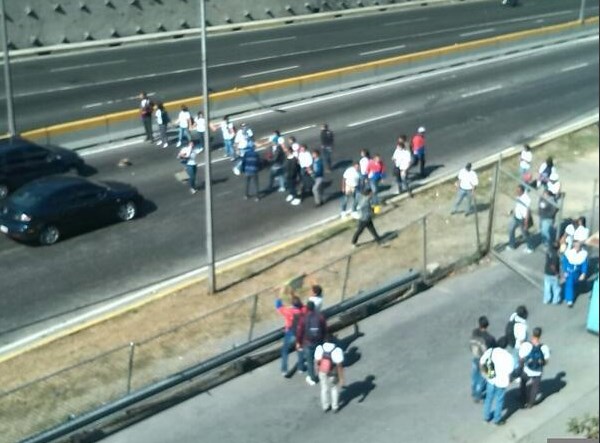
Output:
[315,334,345,413]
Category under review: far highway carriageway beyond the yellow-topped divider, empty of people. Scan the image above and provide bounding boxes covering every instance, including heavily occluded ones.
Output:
[0,0,598,133]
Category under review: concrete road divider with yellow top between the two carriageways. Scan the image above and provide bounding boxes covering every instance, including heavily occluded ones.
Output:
[22,17,598,149]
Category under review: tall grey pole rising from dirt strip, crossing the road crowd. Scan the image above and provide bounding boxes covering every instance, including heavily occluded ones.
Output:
[200,0,216,294]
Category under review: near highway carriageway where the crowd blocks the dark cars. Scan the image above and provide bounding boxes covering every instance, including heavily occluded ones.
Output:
[0,36,599,345]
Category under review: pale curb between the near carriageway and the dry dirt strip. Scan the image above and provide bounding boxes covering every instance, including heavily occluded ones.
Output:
[0,112,600,364]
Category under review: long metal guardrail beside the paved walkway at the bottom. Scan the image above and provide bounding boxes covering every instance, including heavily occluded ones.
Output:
[23,270,421,443]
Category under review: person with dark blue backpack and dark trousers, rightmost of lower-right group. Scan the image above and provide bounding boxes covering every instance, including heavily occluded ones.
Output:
[519,328,550,408]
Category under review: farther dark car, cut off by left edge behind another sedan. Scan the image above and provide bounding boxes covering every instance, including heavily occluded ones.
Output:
[0,137,84,200]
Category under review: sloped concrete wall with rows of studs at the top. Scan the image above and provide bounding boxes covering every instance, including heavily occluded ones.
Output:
[5,0,411,49]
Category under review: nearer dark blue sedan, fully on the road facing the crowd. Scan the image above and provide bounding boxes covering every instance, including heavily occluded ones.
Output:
[0,176,142,245]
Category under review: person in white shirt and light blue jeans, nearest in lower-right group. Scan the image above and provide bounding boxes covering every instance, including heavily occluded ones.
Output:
[479,337,515,425]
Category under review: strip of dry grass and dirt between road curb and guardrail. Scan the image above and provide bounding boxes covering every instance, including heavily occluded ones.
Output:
[0,126,598,441]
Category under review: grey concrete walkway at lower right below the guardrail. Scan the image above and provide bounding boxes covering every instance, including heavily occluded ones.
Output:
[105,256,599,443]
